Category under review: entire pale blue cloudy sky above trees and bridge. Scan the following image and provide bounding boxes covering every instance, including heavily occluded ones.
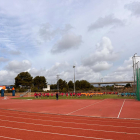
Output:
[0,0,140,85]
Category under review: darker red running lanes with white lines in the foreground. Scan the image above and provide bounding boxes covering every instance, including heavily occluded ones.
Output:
[0,109,140,140]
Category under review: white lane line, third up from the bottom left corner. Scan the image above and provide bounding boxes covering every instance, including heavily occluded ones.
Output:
[0,119,140,135]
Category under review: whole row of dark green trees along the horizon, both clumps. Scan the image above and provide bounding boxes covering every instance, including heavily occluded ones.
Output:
[14,72,94,92]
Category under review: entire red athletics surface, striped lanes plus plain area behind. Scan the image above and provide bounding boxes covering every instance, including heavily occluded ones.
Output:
[0,98,140,140]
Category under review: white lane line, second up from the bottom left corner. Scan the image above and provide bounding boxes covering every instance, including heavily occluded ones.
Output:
[0,126,113,140]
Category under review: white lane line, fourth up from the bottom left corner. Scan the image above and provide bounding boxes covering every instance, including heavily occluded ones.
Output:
[0,115,140,128]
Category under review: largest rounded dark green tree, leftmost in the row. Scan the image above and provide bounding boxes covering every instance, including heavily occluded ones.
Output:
[15,72,33,88]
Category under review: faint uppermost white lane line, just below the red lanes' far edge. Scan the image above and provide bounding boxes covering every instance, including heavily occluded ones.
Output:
[2,112,140,124]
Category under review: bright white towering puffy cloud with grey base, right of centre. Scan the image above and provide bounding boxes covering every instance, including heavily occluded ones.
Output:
[82,37,119,71]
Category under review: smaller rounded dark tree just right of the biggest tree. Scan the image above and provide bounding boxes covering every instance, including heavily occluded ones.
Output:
[34,76,47,89]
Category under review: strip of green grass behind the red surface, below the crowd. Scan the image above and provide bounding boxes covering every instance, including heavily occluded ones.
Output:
[12,95,136,100]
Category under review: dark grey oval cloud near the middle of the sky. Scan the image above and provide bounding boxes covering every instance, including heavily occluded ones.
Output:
[51,33,82,53]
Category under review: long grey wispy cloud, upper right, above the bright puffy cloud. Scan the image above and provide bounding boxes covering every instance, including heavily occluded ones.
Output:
[88,15,124,31]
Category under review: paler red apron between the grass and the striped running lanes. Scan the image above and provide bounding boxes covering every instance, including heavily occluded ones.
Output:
[0,98,140,119]
